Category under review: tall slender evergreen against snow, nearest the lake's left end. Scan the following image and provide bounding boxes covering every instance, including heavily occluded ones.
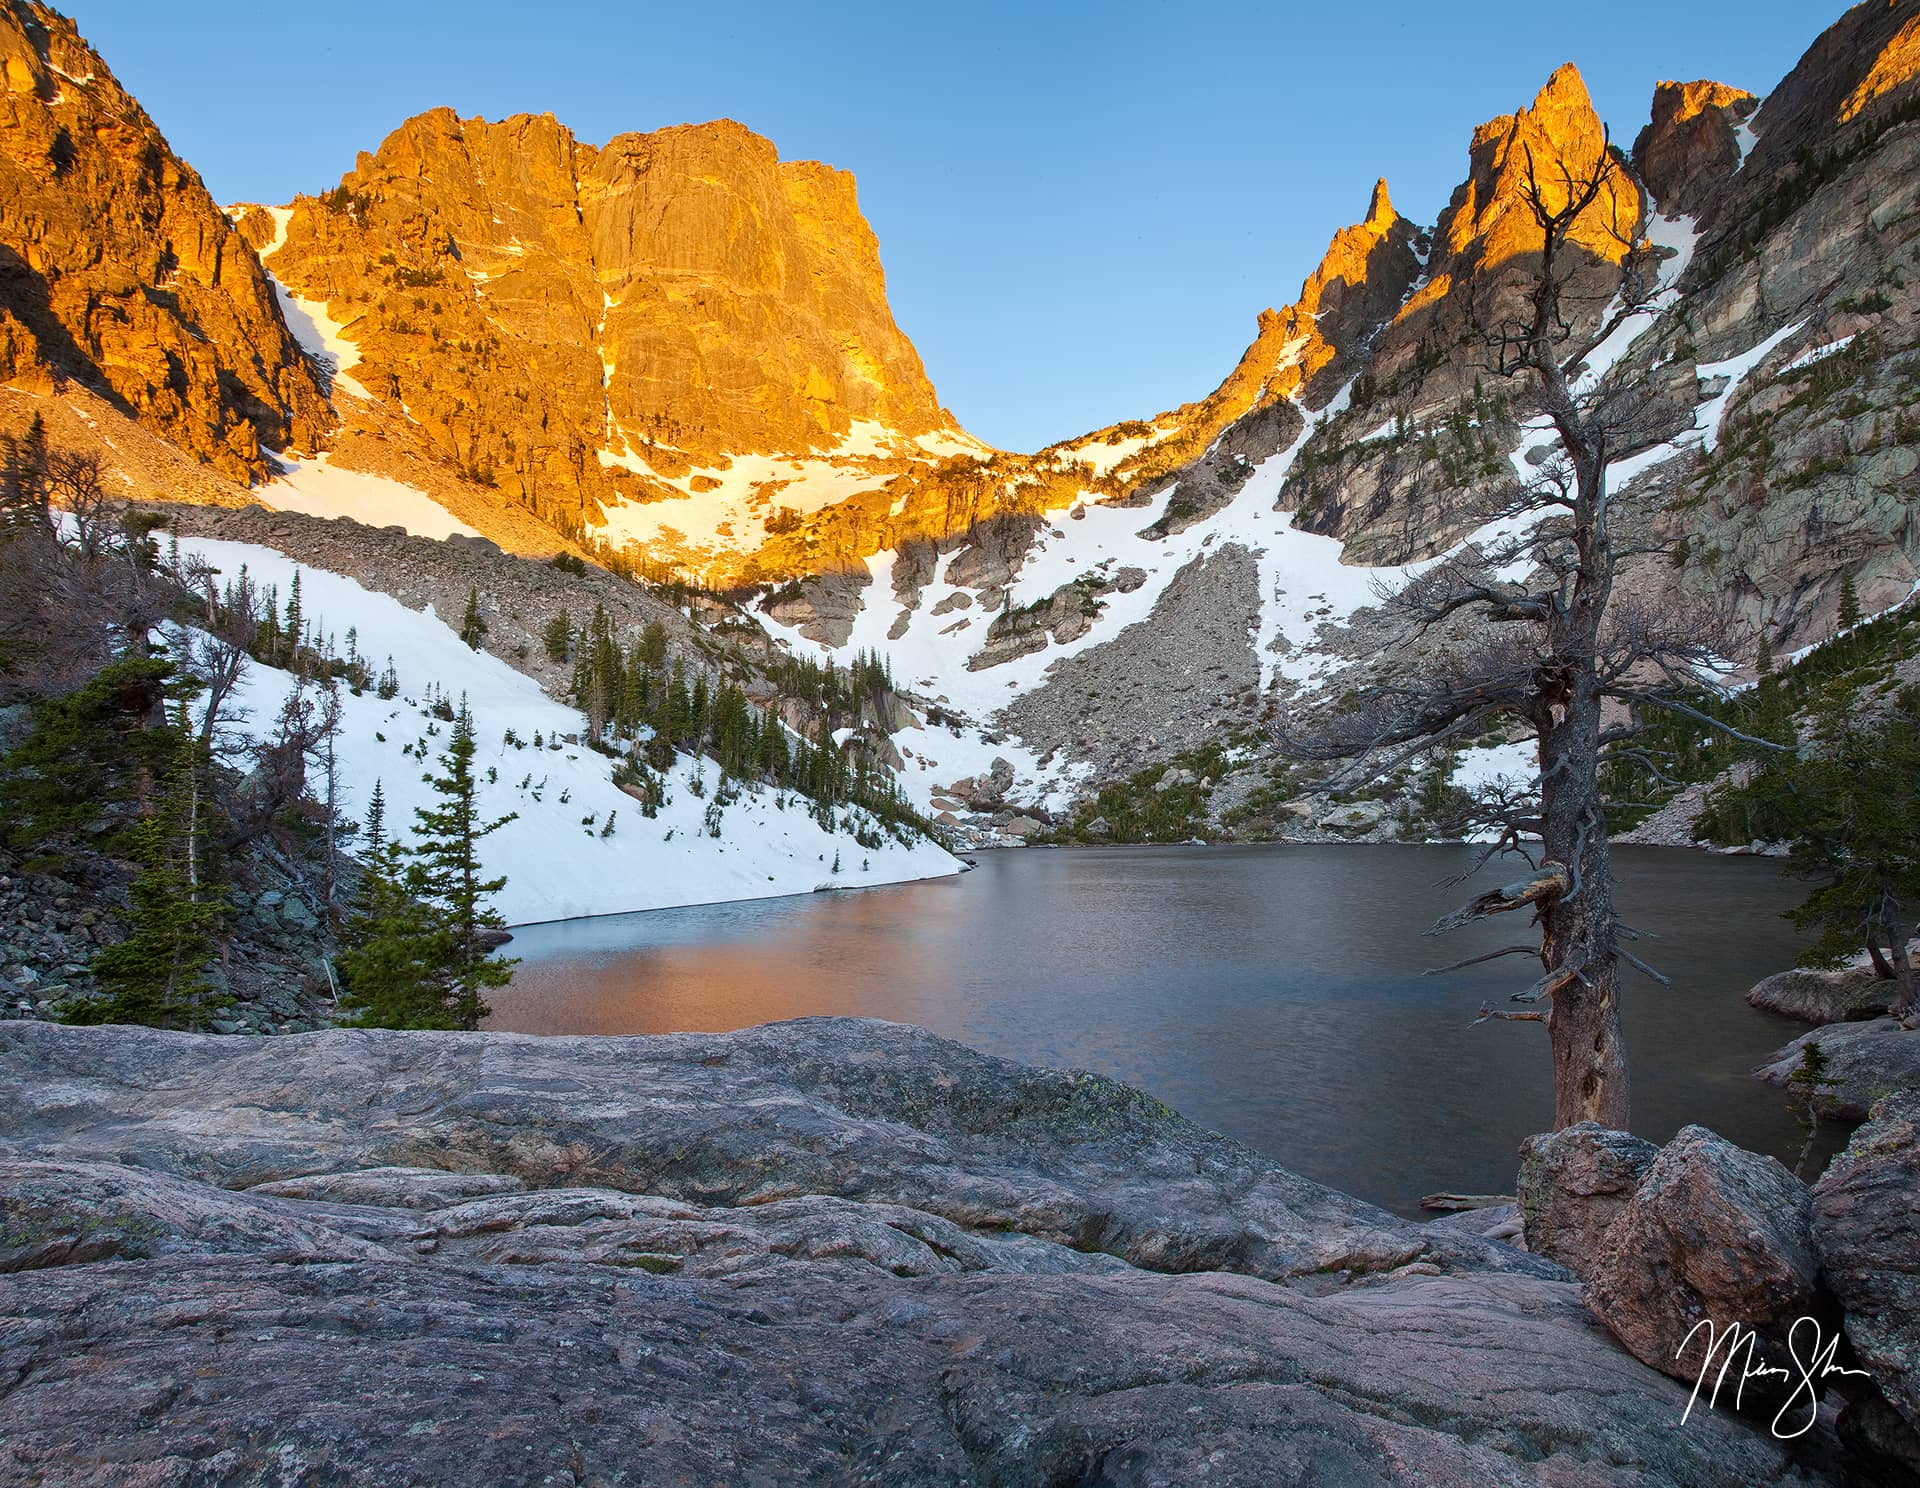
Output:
[407,697,515,1029]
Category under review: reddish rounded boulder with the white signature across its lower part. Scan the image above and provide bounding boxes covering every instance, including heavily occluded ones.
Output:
[1584,1127,1830,1425]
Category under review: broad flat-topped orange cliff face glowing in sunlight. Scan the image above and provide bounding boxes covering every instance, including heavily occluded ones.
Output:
[242,109,952,560]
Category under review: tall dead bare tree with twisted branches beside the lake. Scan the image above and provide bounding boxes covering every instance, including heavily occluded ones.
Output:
[1283,130,1758,1127]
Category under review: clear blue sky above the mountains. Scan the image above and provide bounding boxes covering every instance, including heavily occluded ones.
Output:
[63,0,1845,449]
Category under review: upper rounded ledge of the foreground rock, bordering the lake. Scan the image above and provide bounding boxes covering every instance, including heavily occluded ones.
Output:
[0,1020,1540,1277]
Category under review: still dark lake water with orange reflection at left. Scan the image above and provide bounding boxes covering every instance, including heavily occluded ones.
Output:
[488,845,1827,1213]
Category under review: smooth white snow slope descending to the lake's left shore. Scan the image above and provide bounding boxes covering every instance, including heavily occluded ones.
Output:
[180,540,960,924]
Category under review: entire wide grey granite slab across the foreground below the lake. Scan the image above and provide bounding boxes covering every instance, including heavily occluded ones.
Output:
[0,1020,1816,1488]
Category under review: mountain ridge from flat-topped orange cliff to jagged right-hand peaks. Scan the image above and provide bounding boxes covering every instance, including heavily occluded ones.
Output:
[8,0,1920,837]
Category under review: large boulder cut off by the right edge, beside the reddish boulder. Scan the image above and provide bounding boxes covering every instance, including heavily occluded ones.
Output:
[1812,1091,1920,1430]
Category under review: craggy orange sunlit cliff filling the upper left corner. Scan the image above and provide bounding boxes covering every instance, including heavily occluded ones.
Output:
[0,0,330,484]
